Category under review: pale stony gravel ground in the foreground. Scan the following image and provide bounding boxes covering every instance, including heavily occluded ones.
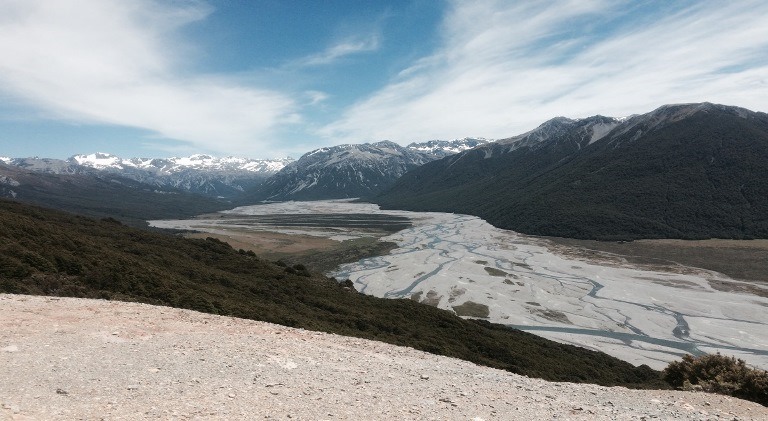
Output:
[0,294,768,420]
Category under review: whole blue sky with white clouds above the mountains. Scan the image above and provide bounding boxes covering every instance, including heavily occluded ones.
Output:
[0,0,768,158]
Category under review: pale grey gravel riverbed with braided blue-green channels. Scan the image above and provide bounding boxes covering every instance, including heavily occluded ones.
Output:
[153,201,768,369]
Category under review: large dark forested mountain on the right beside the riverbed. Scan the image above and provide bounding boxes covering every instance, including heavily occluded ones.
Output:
[375,103,768,240]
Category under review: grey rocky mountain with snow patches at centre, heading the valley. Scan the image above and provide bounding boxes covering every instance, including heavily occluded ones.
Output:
[248,138,488,200]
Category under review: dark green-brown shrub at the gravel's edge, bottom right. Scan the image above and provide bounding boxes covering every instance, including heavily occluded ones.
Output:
[662,353,768,406]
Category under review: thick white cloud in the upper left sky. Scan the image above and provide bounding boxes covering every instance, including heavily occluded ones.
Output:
[0,0,298,155]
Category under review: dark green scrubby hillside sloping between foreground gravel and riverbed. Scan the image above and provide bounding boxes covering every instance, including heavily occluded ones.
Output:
[0,200,664,387]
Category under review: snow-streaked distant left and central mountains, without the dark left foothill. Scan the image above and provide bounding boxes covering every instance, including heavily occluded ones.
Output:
[0,138,488,204]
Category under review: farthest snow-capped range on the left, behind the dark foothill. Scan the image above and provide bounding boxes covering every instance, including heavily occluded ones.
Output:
[3,153,293,198]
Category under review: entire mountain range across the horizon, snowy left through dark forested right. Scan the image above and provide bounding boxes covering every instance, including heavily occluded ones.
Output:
[0,103,768,240]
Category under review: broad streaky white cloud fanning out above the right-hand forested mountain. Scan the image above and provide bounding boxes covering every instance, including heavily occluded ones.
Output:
[319,0,768,142]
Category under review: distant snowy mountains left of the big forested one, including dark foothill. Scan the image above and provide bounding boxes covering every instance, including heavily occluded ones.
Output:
[0,138,487,218]
